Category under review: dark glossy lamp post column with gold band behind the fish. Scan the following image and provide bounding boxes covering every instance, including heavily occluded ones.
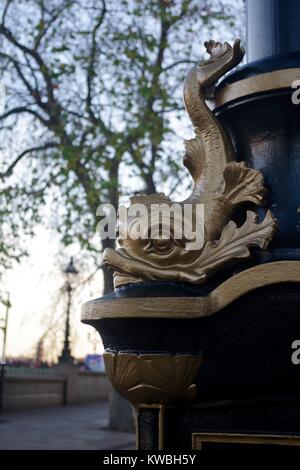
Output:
[215,0,300,263]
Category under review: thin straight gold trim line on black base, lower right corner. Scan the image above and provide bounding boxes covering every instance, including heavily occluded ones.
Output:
[192,432,300,450]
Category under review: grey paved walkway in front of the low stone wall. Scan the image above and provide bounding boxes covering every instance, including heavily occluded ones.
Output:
[0,402,135,450]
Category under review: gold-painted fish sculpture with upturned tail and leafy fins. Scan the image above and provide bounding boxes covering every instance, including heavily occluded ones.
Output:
[103,40,276,287]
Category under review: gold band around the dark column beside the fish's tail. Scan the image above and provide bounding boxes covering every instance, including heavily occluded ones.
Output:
[209,68,300,109]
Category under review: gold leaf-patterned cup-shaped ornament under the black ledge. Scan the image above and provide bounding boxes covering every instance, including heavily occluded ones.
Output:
[104,352,202,405]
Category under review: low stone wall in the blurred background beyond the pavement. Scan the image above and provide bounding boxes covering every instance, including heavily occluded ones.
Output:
[3,366,108,410]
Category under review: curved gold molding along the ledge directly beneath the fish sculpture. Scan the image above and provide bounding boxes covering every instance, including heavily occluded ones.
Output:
[81,261,300,321]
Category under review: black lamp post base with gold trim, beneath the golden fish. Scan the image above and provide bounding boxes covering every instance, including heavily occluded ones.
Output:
[82,261,300,450]
